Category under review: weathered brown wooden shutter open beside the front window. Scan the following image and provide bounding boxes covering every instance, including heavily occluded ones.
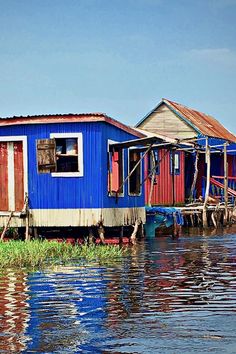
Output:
[37,139,56,173]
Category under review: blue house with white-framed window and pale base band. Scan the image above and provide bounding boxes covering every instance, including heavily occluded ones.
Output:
[0,113,145,231]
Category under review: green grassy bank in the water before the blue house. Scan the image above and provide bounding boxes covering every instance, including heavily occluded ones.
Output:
[0,241,125,269]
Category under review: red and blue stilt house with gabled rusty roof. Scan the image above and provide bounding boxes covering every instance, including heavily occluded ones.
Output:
[136,99,236,205]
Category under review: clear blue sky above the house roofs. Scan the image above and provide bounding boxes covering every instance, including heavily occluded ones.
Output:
[0,0,236,133]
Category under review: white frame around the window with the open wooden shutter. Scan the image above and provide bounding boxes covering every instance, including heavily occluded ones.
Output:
[50,133,84,177]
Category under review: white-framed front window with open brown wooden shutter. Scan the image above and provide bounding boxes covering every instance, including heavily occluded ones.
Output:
[37,133,83,177]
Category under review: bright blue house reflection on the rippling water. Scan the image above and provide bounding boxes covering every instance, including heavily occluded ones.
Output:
[25,267,106,353]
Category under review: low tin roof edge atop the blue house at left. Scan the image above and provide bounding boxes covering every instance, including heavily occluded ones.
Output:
[0,113,144,138]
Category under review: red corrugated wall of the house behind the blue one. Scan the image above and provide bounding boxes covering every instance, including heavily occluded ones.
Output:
[145,149,185,205]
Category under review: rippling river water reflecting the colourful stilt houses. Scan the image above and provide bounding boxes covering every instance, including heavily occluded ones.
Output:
[0,229,236,354]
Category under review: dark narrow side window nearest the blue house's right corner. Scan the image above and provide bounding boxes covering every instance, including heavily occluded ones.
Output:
[128,149,141,195]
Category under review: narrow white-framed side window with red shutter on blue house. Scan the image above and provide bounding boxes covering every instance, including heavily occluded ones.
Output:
[108,150,124,196]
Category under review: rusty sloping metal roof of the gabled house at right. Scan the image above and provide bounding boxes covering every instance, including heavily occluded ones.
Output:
[162,98,236,142]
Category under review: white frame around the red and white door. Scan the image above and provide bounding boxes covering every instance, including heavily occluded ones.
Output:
[0,135,28,215]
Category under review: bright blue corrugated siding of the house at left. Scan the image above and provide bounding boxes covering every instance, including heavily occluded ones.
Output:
[0,122,144,209]
